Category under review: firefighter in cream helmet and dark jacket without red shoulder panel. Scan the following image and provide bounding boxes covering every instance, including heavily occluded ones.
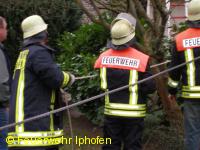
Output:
[8,15,74,150]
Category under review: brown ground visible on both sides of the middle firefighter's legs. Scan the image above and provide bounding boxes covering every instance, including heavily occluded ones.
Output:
[60,108,183,150]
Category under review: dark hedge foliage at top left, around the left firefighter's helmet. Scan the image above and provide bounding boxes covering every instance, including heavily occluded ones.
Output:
[0,0,82,66]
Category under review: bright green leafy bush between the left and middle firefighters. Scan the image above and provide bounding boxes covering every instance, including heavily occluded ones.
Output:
[58,24,109,124]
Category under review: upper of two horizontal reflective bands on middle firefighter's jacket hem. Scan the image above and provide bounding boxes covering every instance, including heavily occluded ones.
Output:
[105,103,146,110]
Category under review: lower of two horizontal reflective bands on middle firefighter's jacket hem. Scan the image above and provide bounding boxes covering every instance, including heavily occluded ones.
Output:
[104,108,146,117]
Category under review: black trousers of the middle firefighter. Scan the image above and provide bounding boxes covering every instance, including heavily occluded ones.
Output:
[102,115,144,150]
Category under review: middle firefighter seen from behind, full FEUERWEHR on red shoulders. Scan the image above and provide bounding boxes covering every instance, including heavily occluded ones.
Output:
[94,13,155,150]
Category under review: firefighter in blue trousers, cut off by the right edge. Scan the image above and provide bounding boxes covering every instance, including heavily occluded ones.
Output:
[168,0,200,150]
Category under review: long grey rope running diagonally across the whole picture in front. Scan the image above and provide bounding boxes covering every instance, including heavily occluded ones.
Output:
[0,56,200,131]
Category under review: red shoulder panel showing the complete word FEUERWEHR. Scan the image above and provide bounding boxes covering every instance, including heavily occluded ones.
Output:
[94,47,149,72]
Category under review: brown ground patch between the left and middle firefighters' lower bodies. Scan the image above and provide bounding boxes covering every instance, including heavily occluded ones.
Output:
[61,108,103,150]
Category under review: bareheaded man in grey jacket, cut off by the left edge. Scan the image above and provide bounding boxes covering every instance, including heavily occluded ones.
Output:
[0,16,12,150]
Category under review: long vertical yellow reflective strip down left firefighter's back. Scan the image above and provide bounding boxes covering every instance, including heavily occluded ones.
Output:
[15,50,29,132]
